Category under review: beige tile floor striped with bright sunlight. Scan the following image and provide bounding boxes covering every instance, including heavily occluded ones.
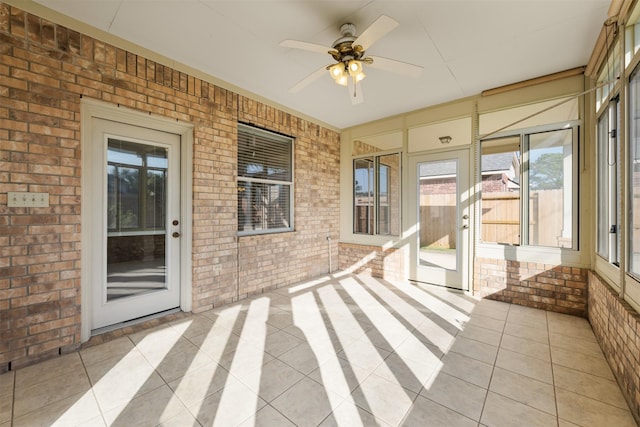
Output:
[0,275,636,427]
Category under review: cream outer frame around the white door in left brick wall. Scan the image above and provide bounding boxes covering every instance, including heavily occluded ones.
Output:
[80,98,193,342]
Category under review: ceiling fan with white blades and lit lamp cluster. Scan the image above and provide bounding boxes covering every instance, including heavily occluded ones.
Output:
[280,15,422,104]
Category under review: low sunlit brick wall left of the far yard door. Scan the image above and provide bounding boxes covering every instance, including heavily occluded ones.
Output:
[339,243,407,280]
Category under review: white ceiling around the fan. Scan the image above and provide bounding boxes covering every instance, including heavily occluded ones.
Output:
[35,0,610,129]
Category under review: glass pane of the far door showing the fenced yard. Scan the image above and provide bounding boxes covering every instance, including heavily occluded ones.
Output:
[418,159,458,270]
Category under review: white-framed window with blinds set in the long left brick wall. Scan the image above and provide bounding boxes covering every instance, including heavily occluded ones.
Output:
[238,123,293,235]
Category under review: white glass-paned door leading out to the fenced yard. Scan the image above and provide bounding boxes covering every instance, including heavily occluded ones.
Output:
[409,150,472,290]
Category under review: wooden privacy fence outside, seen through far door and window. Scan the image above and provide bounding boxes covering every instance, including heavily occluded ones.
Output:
[420,189,563,248]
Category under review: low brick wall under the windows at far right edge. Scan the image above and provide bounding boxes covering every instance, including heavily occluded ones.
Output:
[588,271,640,423]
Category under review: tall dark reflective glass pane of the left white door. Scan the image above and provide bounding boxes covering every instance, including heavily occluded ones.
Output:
[107,139,168,301]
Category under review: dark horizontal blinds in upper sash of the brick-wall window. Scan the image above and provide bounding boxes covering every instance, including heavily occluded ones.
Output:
[238,124,293,182]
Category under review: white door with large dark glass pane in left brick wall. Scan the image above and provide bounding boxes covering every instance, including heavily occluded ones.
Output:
[89,118,181,330]
